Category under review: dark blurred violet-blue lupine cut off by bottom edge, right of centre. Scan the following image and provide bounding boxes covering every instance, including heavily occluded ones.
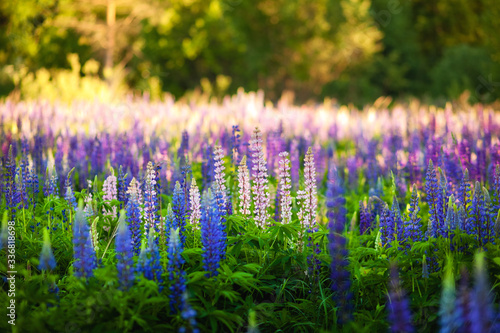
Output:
[387,265,414,333]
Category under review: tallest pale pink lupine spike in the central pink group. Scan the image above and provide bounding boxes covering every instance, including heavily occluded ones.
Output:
[250,127,270,228]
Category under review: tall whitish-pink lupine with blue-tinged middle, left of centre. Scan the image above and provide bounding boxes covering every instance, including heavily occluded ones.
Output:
[144,162,159,233]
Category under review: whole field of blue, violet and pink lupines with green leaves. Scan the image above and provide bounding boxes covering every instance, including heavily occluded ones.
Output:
[0,92,500,333]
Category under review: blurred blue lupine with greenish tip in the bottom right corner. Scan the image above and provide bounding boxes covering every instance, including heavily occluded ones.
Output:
[469,252,495,332]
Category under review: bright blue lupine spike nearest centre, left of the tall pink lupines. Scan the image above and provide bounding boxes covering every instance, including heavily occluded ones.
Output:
[200,190,226,276]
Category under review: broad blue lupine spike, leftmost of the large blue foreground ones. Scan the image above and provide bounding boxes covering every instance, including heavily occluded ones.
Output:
[73,207,97,278]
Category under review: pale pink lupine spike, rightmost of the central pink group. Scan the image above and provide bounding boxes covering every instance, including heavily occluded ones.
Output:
[297,147,318,231]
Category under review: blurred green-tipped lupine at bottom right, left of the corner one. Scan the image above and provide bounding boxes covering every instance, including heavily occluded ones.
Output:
[439,256,460,333]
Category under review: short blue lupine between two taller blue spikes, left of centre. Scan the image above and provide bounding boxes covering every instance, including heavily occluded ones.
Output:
[136,228,163,291]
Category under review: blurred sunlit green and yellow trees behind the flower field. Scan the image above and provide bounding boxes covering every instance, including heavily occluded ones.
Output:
[0,0,500,105]
